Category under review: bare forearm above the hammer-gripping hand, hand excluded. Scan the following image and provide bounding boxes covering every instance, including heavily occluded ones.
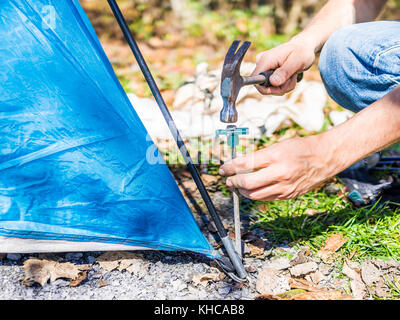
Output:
[294,0,386,52]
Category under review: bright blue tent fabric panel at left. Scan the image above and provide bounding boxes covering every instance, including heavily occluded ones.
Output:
[0,0,215,257]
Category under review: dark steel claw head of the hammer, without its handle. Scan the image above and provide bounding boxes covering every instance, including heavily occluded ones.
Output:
[220,40,251,123]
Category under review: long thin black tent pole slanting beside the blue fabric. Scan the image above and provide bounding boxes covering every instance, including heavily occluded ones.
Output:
[107,0,247,280]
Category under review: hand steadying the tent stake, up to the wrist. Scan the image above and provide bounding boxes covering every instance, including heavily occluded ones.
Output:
[220,136,337,201]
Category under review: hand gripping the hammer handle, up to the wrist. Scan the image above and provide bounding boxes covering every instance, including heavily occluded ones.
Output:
[252,38,315,95]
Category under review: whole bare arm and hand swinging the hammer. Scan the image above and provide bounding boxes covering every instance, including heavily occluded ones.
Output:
[253,0,386,94]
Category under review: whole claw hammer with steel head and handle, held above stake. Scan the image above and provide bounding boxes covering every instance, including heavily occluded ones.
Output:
[220,40,303,123]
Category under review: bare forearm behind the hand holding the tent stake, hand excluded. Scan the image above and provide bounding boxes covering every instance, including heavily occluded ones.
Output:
[318,86,400,176]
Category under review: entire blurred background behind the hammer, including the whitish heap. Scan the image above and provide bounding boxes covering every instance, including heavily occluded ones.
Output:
[80,0,400,168]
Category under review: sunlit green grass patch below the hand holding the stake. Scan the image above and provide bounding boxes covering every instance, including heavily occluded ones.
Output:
[247,191,400,261]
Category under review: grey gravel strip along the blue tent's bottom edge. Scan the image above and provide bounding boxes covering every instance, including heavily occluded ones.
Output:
[0,251,257,300]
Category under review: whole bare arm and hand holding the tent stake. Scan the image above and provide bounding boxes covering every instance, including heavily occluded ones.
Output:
[220,86,400,201]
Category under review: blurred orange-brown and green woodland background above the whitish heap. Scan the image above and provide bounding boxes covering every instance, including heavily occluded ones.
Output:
[80,0,400,100]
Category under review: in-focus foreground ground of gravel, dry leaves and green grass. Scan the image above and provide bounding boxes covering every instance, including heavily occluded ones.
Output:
[0,168,400,300]
